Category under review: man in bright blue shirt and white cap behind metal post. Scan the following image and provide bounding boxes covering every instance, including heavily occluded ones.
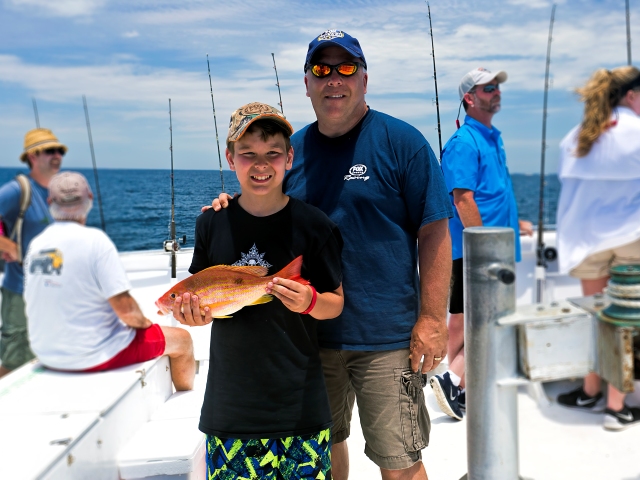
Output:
[431,68,533,420]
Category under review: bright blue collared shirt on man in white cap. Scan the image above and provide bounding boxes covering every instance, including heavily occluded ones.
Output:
[442,115,520,262]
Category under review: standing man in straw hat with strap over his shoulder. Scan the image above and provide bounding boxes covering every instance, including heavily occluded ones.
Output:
[0,128,67,377]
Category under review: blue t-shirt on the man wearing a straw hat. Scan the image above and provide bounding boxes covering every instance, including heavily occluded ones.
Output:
[0,177,53,295]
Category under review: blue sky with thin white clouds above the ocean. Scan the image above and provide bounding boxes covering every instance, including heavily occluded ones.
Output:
[0,0,640,173]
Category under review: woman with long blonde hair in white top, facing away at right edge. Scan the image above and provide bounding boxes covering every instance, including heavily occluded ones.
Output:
[557,66,640,430]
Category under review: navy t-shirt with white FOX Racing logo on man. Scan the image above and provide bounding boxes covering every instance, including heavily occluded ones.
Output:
[284,109,452,350]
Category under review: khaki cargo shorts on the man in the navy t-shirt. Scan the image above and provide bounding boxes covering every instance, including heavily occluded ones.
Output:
[320,348,431,470]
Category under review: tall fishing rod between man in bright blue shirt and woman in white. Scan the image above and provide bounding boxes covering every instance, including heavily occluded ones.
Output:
[536,3,556,303]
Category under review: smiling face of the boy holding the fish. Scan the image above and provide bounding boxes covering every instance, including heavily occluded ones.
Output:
[226,131,293,195]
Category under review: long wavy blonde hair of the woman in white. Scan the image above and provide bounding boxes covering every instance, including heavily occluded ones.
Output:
[576,66,640,157]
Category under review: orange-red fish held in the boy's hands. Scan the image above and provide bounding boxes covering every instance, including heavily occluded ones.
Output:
[156,255,309,318]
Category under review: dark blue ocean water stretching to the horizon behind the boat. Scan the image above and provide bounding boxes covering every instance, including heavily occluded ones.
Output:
[0,168,560,252]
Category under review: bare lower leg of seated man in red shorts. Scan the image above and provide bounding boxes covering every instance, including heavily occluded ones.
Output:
[160,327,196,391]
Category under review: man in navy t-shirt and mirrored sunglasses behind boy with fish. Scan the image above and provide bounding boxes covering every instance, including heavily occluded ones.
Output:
[214,30,452,480]
